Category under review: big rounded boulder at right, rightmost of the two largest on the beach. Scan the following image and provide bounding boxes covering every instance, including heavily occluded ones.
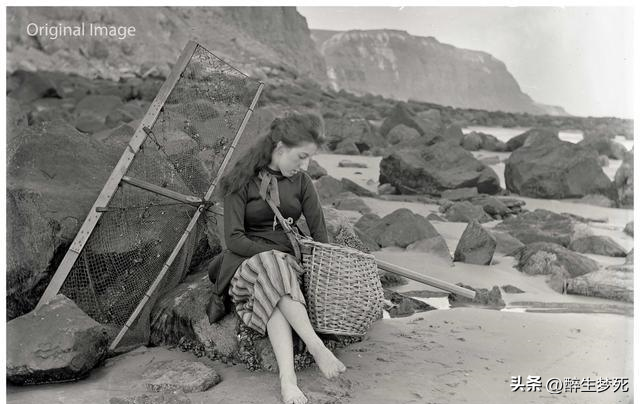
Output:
[504,133,617,199]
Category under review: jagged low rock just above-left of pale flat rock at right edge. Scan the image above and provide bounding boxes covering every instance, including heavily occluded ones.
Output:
[515,242,599,293]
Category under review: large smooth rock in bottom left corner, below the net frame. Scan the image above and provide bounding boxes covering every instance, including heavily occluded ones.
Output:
[6,295,110,384]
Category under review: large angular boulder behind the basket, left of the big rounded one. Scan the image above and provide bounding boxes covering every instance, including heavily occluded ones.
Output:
[379,142,500,195]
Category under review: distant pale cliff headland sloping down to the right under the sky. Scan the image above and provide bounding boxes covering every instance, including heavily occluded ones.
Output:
[312,30,566,114]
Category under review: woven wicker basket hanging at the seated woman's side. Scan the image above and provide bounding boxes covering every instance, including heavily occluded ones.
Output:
[299,239,383,336]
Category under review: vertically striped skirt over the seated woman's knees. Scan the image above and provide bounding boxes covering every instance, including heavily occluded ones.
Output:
[229,250,306,335]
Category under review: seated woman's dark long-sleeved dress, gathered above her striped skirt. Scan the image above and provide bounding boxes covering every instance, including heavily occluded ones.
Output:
[210,168,328,310]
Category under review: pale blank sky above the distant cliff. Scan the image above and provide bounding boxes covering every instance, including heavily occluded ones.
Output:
[297,7,634,118]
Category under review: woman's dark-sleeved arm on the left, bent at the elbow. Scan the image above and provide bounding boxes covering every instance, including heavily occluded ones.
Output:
[224,187,273,257]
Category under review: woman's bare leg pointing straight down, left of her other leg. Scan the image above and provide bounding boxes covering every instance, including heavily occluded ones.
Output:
[267,308,307,404]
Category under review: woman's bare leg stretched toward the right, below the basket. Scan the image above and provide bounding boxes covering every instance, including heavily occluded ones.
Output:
[278,296,346,379]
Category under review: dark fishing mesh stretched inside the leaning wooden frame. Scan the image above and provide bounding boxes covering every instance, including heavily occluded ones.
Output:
[55,45,260,345]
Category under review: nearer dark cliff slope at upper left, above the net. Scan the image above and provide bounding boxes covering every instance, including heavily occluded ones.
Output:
[7,7,326,82]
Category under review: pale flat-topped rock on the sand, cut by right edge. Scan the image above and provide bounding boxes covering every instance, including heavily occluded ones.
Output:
[565,268,633,302]
